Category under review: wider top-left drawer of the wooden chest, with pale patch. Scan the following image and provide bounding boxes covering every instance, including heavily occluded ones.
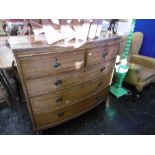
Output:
[19,50,85,78]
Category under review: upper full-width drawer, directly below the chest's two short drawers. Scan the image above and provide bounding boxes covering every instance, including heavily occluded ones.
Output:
[25,58,115,97]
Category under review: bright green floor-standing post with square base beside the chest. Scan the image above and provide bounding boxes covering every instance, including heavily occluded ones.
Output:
[110,19,136,98]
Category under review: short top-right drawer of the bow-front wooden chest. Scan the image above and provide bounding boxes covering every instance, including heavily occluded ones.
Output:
[86,44,118,66]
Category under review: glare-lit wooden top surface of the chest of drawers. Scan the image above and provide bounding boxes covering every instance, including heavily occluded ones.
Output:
[8,35,121,53]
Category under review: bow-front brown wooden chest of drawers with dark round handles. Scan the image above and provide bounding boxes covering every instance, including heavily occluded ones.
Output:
[9,36,120,131]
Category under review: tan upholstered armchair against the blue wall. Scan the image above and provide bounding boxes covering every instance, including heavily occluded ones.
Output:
[124,32,155,91]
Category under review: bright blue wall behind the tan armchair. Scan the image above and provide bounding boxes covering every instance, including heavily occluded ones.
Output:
[135,19,155,58]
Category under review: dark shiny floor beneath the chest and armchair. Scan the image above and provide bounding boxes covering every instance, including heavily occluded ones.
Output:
[0,84,155,135]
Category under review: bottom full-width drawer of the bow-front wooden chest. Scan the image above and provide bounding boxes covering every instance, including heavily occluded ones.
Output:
[34,88,109,129]
